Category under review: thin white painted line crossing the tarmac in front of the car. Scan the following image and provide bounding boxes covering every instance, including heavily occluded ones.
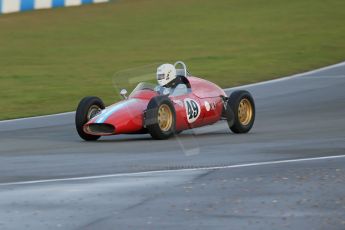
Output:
[0,155,345,186]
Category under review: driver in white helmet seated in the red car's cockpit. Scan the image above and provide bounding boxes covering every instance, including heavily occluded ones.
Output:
[157,64,187,94]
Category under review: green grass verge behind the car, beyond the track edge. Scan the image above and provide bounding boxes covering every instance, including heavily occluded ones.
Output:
[0,0,345,119]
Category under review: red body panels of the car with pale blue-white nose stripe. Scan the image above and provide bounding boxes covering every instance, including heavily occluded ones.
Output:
[84,77,226,135]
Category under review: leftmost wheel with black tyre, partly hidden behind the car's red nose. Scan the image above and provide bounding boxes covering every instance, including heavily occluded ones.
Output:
[75,97,105,141]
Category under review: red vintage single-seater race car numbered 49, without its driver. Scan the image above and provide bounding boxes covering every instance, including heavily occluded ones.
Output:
[75,62,255,141]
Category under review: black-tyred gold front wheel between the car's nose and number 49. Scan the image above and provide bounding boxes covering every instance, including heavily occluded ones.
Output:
[145,96,176,140]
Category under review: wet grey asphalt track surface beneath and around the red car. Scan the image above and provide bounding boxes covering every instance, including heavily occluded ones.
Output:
[0,63,345,230]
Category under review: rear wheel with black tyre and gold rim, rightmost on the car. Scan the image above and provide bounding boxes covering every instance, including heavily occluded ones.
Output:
[227,90,255,133]
